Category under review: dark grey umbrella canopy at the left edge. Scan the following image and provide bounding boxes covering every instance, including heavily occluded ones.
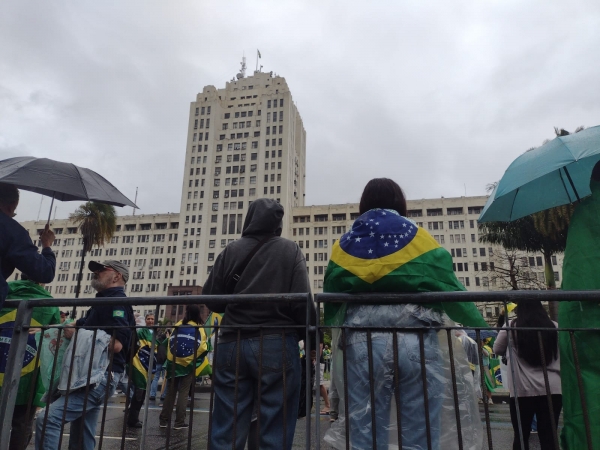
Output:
[0,156,137,208]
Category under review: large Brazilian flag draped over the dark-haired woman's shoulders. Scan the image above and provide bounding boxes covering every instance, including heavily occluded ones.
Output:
[323,209,488,327]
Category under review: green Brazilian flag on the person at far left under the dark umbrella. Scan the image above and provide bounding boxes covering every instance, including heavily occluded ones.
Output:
[0,280,60,407]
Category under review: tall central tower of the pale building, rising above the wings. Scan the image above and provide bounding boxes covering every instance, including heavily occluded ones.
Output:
[177,63,306,286]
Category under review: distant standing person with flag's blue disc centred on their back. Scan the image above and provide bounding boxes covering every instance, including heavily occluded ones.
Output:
[159,305,210,430]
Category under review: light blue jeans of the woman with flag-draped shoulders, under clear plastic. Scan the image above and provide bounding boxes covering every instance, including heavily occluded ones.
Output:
[346,330,444,450]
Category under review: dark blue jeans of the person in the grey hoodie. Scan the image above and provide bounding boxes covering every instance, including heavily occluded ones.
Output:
[210,334,302,450]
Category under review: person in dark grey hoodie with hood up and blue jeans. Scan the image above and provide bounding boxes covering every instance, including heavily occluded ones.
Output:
[202,198,316,450]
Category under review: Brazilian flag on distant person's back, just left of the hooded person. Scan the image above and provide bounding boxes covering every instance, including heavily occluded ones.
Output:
[165,321,211,378]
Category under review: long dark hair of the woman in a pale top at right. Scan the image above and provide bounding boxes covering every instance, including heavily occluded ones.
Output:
[513,300,558,367]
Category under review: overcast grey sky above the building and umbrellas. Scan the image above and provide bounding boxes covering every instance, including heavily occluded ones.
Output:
[0,0,600,220]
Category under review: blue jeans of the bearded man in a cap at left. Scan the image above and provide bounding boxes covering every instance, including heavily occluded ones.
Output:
[35,373,123,450]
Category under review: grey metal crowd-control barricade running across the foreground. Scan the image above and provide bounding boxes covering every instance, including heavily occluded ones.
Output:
[0,291,600,450]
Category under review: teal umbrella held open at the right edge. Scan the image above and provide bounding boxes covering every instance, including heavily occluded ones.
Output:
[479,126,600,222]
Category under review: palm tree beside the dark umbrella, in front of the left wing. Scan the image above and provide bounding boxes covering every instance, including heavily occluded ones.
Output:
[69,202,117,298]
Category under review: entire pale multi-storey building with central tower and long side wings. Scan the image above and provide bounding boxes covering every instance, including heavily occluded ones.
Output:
[11,69,562,319]
